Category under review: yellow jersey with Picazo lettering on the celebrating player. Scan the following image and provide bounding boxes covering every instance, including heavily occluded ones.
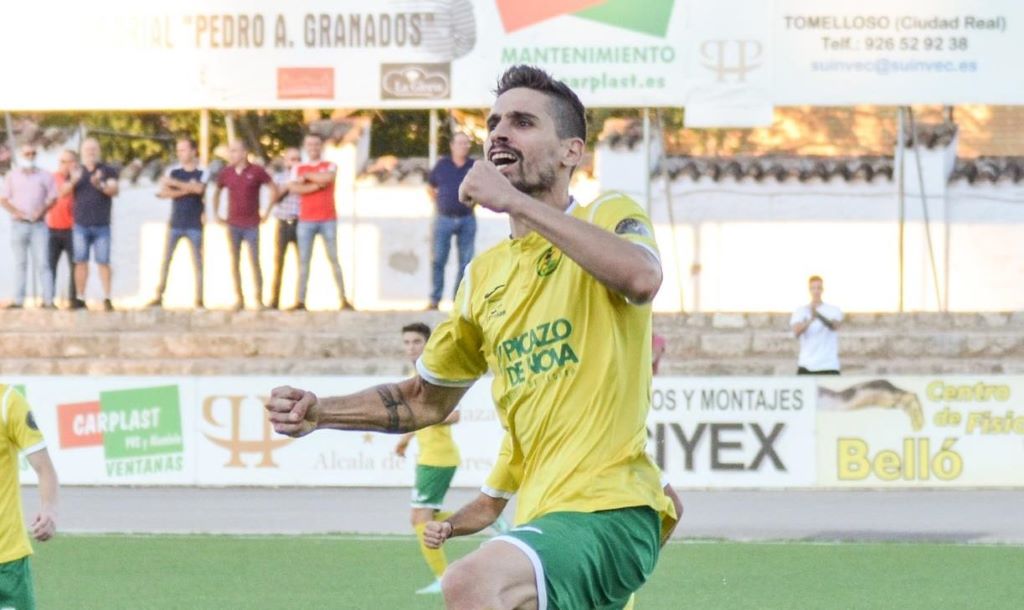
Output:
[417,192,675,523]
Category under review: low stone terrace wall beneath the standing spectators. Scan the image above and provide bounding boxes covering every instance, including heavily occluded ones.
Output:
[0,310,1024,376]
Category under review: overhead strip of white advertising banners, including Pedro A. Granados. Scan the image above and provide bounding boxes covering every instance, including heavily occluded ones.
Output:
[0,0,1024,110]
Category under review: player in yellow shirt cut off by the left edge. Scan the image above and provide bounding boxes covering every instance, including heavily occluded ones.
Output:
[0,384,57,610]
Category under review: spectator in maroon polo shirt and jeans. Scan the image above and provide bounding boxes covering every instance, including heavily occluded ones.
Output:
[213,140,278,309]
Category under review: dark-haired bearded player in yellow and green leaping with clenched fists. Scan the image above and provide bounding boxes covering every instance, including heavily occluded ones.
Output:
[266,66,676,609]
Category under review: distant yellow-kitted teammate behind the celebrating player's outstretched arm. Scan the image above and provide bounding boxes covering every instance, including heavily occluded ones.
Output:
[394,322,461,595]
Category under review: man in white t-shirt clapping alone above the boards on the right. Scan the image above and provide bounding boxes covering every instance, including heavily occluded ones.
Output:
[790,275,843,375]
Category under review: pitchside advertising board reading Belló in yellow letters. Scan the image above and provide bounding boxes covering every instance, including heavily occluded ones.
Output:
[817,376,1024,487]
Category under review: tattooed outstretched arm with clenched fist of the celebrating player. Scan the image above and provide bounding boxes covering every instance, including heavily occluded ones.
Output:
[266,377,469,437]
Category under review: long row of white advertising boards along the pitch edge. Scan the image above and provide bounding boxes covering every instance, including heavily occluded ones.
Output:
[14,376,1024,488]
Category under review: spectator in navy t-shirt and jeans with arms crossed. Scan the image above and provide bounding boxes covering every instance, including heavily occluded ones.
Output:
[147,137,209,309]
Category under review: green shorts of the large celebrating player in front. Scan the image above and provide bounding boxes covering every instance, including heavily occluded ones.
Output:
[493,507,660,610]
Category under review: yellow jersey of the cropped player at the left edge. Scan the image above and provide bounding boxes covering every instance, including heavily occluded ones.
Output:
[0,384,46,563]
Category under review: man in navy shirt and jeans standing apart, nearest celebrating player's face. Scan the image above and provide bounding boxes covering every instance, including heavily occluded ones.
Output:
[427,133,476,309]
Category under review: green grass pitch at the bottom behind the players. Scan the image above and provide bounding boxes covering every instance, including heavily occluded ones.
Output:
[33,534,1024,610]
